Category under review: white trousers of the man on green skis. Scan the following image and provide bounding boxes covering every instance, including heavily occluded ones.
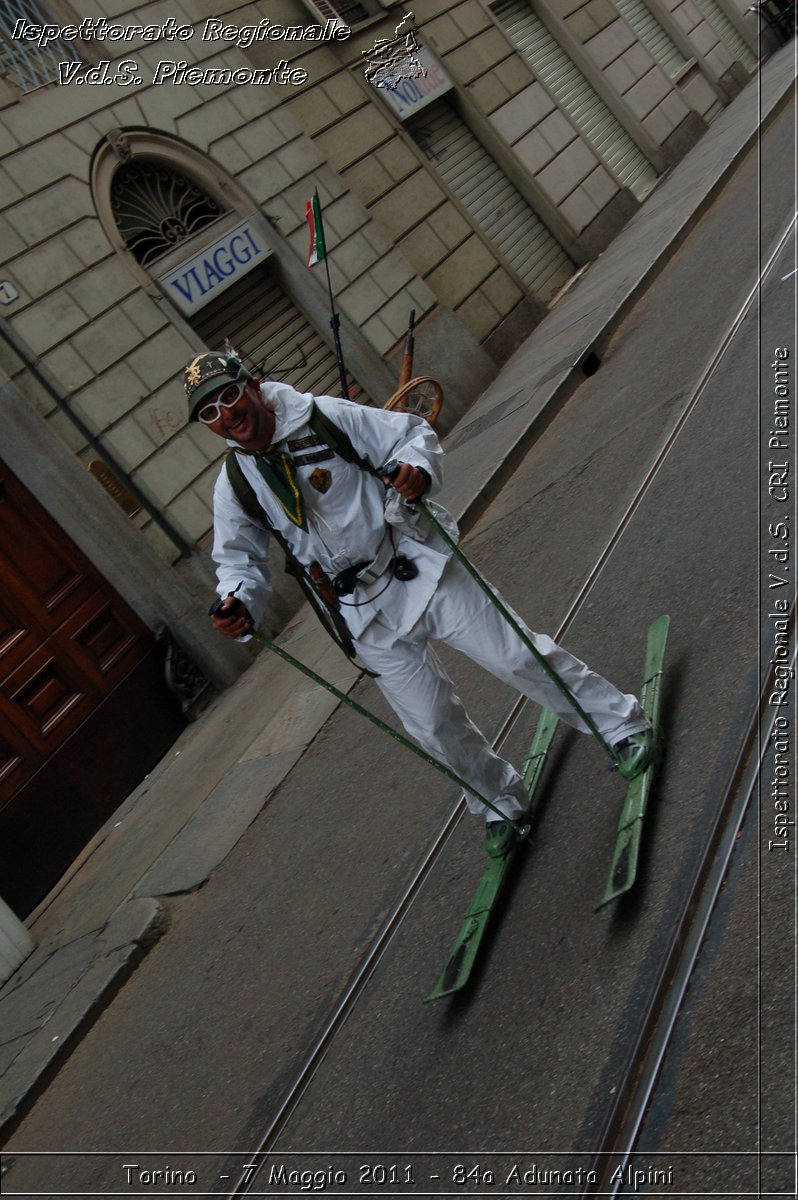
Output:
[355,558,648,820]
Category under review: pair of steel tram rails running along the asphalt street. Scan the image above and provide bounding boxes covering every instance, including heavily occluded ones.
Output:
[228,214,798,1200]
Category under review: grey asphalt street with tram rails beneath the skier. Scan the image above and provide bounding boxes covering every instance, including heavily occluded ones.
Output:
[3,100,794,1195]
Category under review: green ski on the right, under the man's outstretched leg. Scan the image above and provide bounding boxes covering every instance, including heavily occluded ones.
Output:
[595,616,671,912]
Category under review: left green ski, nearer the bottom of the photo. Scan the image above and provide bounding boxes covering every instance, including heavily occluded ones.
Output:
[424,709,557,1003]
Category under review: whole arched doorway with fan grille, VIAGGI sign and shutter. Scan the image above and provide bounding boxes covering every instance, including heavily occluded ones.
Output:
[91,126,392,405]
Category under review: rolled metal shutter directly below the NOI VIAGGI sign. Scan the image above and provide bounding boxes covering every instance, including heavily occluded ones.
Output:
[409,101,576,302]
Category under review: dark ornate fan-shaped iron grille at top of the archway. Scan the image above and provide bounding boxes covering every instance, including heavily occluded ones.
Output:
[110,158,229,266]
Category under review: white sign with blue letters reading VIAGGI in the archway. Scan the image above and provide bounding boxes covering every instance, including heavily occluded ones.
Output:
[158,221,271,316]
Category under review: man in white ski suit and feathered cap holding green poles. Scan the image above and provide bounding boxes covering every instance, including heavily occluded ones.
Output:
[185,354,650,852]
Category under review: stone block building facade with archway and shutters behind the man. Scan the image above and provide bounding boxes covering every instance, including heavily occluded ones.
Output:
[0,0,757,907]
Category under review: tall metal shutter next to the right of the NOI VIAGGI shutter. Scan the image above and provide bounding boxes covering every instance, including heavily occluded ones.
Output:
[492,0,656,200]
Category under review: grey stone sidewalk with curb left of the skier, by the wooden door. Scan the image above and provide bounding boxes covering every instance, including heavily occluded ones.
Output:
[0,610,360,1142]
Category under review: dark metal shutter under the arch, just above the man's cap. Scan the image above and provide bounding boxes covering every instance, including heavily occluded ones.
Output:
[191,263,360,400]
